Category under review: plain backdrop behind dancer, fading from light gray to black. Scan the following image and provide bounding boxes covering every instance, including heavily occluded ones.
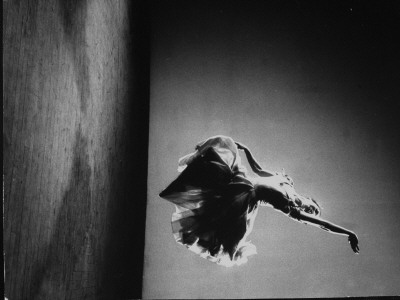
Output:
[143,1,400,298]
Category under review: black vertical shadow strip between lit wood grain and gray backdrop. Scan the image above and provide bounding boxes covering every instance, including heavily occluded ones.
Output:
[100,1,150,299]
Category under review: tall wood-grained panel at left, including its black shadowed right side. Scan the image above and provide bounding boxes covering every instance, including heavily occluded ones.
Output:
[3,0,148,299]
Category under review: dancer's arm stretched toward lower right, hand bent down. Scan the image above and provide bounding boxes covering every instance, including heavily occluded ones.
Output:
[289,210,360,254]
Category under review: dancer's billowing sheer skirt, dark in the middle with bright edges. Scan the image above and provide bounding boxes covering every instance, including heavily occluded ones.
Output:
[160,136,258,266]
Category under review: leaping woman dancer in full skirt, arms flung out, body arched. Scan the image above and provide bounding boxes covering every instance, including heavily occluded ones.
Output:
[160,135,359,266]
